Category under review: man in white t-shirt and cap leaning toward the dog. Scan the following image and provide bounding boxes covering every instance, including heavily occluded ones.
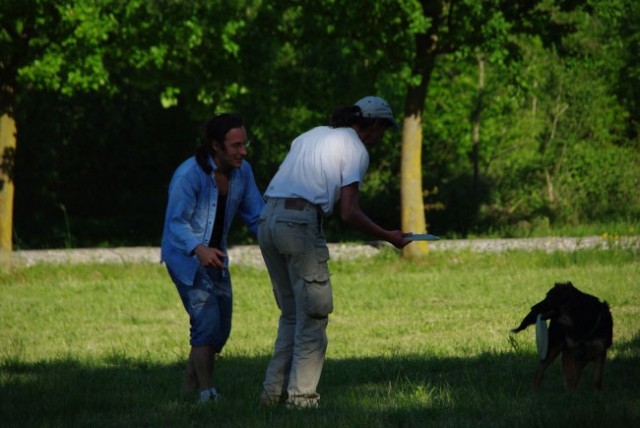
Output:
[258,96,409,407]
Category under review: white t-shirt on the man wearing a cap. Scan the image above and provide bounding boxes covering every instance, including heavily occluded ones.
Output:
[265,126,369,214]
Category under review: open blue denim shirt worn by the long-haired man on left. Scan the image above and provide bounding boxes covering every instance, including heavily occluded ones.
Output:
[161,157,264,285]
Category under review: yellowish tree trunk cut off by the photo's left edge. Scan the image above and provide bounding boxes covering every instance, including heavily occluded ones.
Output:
[0,113,16,267]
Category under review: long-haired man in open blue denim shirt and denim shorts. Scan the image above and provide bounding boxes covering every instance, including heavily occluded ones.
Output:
[162,113,264,402]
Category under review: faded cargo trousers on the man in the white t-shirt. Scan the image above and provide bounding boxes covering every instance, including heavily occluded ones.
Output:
[258,199,333,406]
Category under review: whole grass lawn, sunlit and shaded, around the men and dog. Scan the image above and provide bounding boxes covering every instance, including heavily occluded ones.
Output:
[0,249,640,428]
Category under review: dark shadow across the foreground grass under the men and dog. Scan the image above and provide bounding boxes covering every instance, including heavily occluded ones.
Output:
[0,333,640,428]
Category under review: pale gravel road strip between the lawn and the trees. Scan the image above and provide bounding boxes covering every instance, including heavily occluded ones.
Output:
[13,236,640,267]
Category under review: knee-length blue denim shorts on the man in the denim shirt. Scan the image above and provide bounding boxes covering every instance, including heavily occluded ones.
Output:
[169,266,233,353]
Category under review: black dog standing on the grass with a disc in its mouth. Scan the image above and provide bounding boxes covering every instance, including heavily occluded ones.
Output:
[511,282,613,390]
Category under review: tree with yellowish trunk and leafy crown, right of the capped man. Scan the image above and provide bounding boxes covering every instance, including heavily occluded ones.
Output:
[246,0,592,258]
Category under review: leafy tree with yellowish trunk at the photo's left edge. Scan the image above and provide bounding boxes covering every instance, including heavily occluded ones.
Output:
[0,0,258,253]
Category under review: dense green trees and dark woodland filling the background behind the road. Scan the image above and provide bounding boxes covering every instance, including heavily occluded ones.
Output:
[0,0,640,247]
